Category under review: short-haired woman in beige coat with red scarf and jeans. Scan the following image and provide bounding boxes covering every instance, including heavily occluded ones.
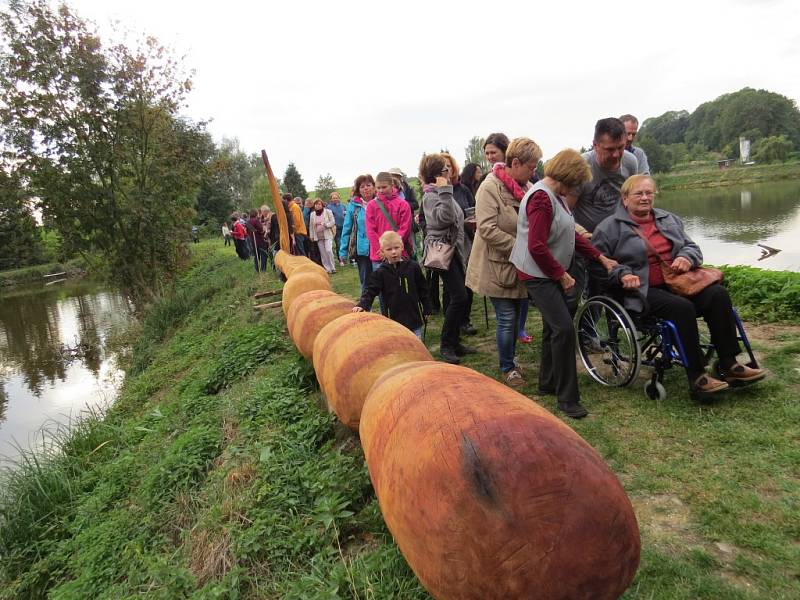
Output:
[467,138,542,387]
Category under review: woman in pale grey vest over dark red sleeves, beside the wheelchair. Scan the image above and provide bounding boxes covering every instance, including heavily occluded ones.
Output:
[511,149,616,419]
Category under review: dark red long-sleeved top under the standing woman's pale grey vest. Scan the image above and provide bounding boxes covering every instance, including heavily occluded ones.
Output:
[517,190,600,281]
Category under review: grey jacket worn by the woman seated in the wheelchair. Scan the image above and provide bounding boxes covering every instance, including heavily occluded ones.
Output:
[592,205,703,312]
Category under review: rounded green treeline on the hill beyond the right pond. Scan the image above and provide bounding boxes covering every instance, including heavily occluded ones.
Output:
[637,88,800,172]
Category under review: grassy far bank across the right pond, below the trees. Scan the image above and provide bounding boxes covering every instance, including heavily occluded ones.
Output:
[655,162,800,191]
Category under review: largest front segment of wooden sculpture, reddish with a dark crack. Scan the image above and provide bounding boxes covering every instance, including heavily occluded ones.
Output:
[360,356,640,600]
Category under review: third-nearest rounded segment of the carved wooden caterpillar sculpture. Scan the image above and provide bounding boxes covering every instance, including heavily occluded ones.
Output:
[286,292,355,360]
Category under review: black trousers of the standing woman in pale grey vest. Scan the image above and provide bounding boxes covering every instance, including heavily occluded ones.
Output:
[525,278,581,404]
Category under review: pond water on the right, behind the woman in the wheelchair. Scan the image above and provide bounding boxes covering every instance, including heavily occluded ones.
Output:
[657,181,800,271]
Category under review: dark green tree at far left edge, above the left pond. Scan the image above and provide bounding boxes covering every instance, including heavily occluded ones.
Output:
[0,168,42,270]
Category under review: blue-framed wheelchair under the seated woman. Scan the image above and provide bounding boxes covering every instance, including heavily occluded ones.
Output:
[575,292,758,400]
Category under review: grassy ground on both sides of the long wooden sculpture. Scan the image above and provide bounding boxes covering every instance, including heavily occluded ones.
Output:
[0,240,800,599]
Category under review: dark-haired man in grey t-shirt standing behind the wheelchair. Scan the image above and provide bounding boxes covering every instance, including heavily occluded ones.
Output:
[574,117,638,233]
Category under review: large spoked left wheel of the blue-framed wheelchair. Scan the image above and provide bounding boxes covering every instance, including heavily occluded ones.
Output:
[575,296,641,387]
